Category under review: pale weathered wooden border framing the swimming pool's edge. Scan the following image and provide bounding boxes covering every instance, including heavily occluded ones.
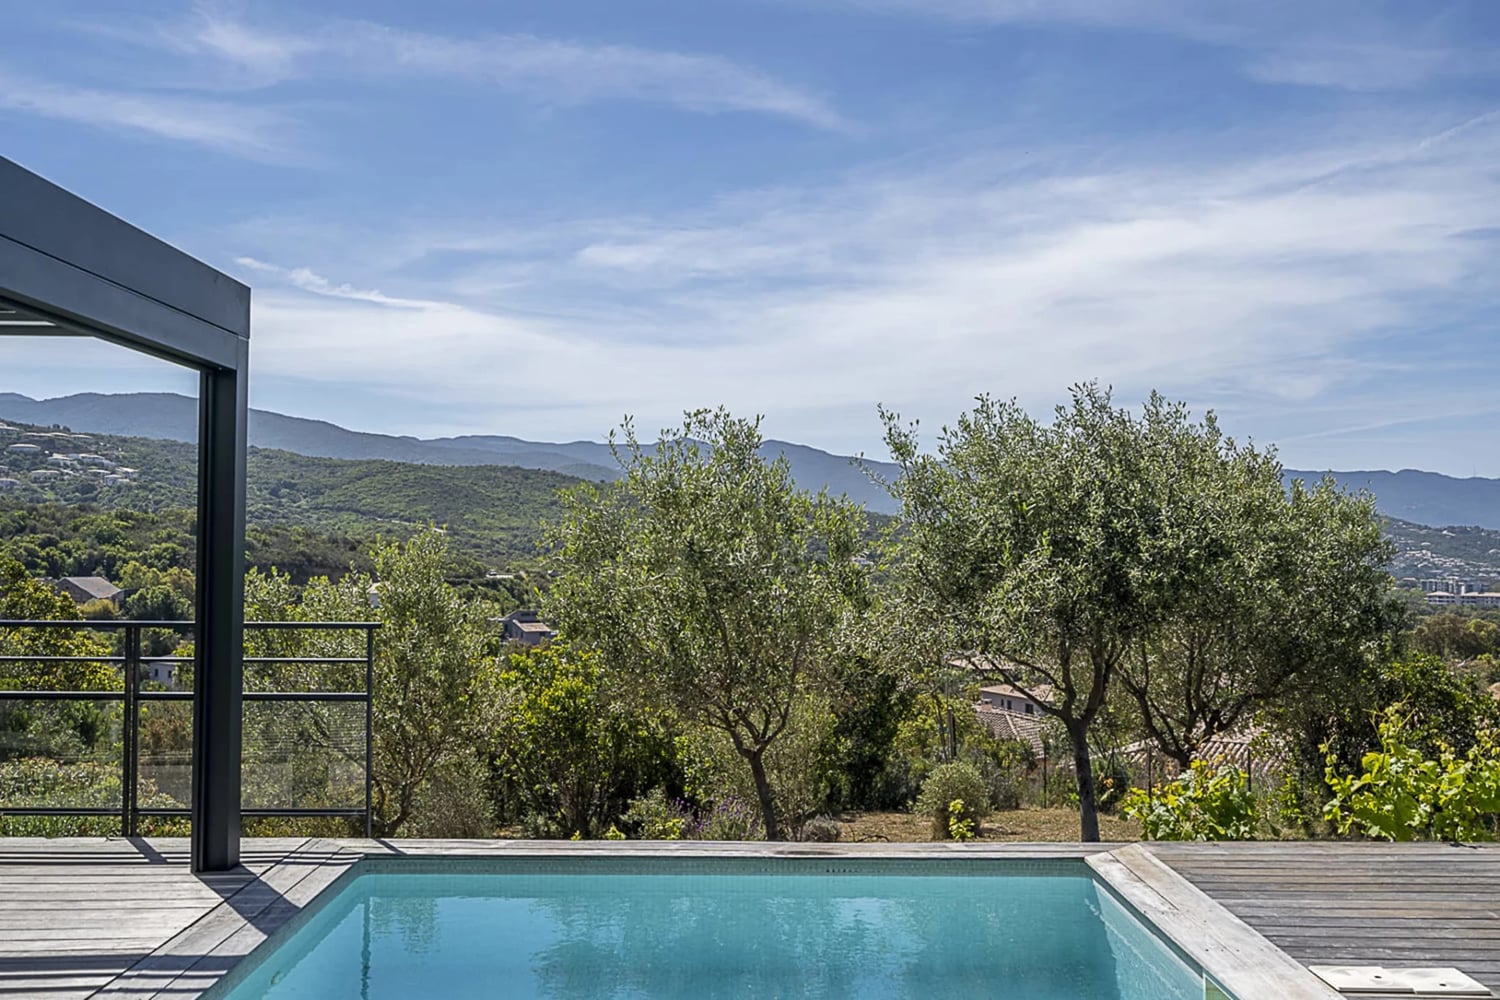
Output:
[108,840,1341,1000]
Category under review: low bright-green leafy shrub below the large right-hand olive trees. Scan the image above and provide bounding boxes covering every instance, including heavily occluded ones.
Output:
[1121,760,1259,840]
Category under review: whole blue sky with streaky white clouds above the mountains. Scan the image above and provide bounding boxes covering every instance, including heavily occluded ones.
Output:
[0,0,1500,477]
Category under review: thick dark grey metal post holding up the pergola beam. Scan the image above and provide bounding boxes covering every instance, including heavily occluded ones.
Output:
[192,353,249,873]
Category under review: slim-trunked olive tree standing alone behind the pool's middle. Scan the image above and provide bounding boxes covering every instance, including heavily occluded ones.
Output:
[546,409,864,840]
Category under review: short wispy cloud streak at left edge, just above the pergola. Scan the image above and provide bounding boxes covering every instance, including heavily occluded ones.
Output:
[0,70,305,163]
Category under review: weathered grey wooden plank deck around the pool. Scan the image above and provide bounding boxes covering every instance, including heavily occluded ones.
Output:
[0,838,1500,1000]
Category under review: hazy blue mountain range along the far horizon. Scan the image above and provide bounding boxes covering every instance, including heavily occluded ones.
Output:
[0,393,1500,529]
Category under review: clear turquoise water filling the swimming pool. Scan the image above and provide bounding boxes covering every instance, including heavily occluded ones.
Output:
[217,861,1203,1000]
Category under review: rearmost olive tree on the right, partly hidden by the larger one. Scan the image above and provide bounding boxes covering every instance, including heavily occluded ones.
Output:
[1119,464,1400,768]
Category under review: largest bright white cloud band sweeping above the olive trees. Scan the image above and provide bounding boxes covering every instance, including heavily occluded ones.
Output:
[228,109,1500,458]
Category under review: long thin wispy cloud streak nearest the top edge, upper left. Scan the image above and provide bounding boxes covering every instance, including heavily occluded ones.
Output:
[128,4,848,130]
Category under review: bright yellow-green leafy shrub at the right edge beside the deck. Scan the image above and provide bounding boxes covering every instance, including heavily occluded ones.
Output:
[1323,706,1500,841]
